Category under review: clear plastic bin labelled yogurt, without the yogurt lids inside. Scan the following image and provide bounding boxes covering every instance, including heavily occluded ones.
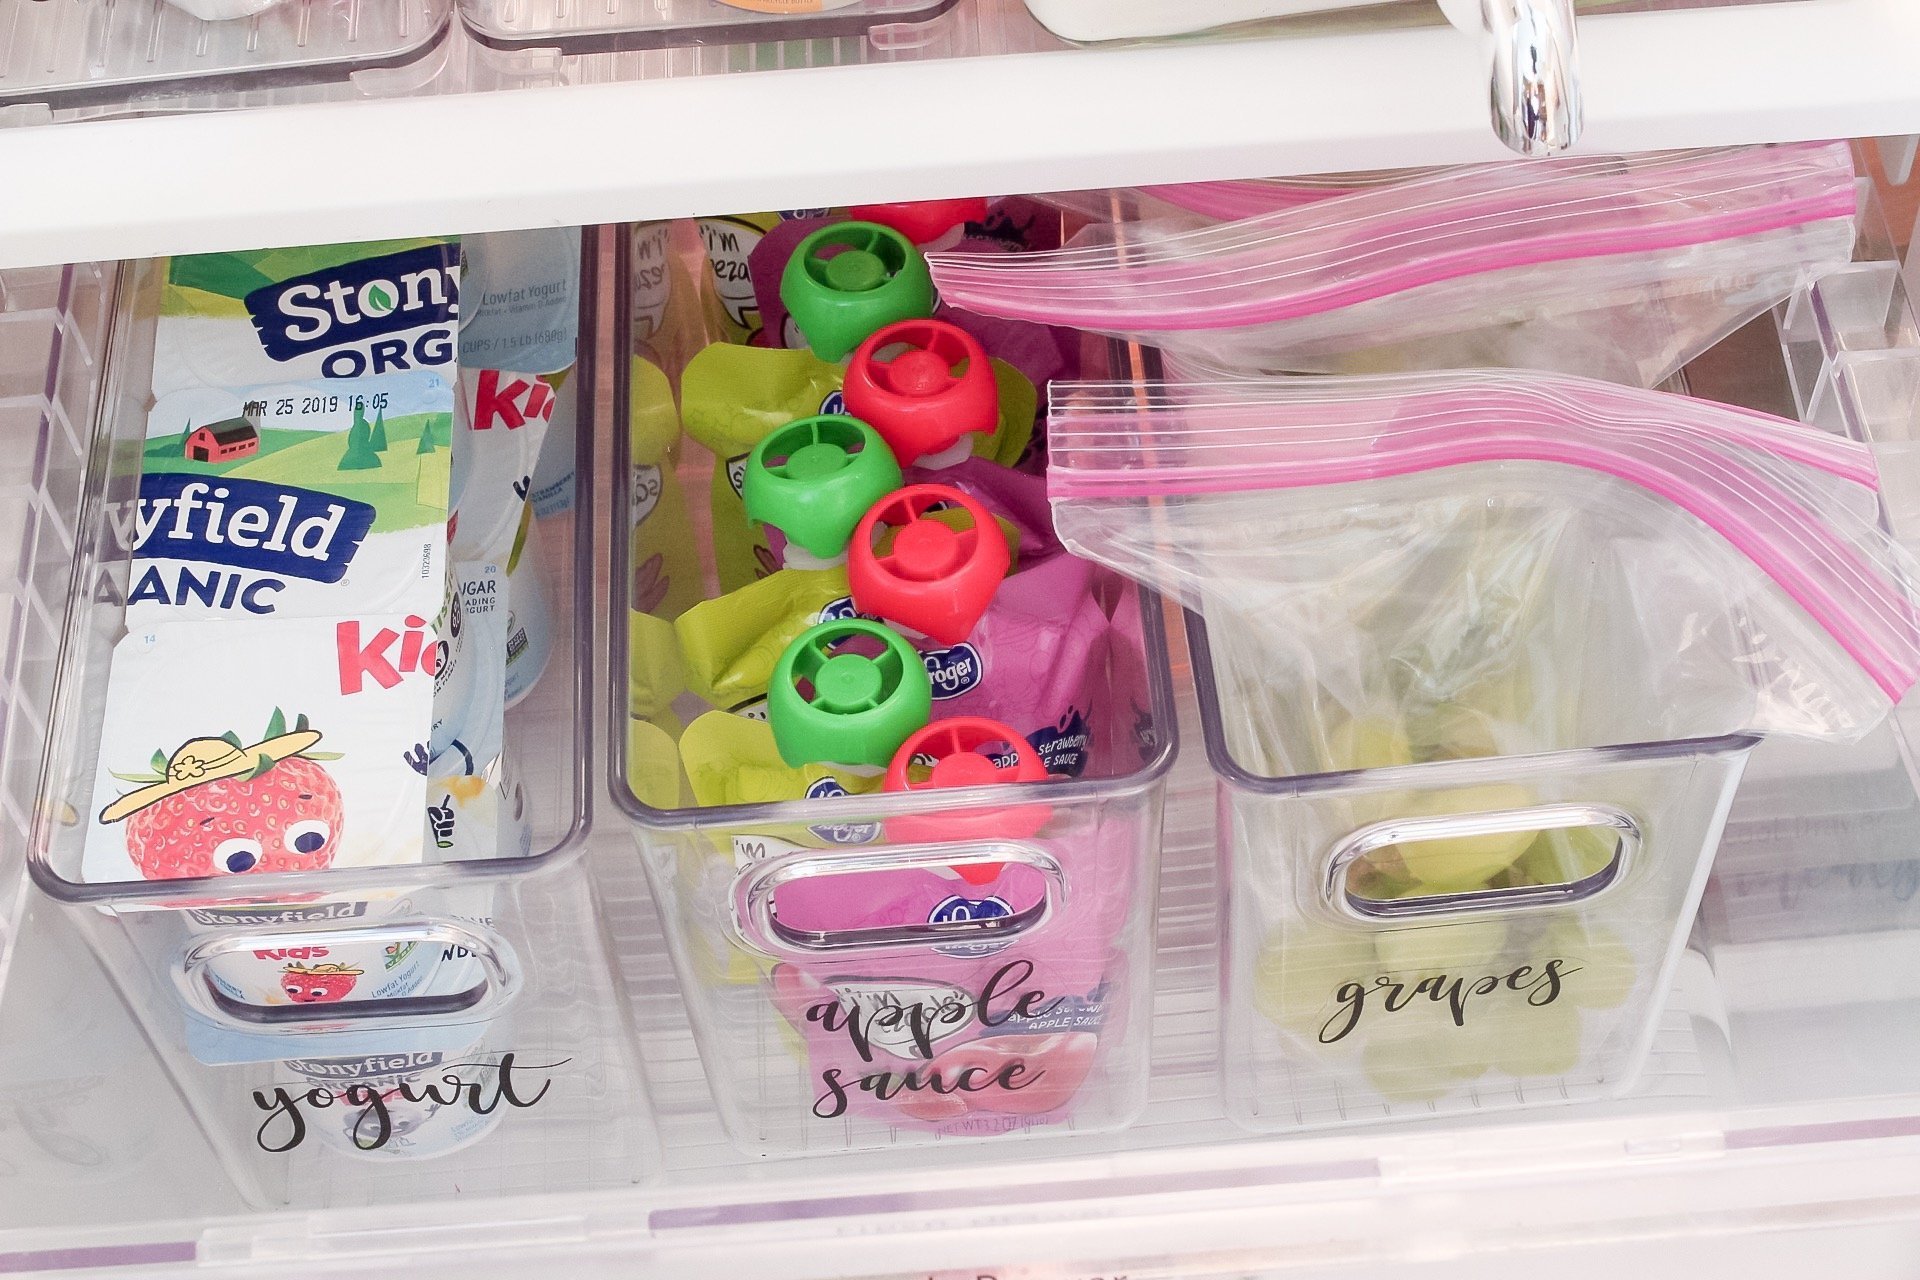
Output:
[16,228,653,1205]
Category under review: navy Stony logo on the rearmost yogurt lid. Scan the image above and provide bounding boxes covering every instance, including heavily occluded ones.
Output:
[242,244,461,361]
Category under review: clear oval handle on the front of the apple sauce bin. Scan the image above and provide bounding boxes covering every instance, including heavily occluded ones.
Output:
[732,841,1068,958]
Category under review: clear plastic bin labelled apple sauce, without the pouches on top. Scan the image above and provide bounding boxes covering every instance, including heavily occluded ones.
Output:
[609,240,1177,1155]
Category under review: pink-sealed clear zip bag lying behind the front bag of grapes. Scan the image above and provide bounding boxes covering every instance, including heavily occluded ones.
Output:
[927,144,1855,386]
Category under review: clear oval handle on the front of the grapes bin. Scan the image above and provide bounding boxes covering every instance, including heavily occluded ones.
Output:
[1323,804,1640,921]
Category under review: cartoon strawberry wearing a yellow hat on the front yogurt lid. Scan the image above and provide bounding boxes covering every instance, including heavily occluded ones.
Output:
[100,708,351,882]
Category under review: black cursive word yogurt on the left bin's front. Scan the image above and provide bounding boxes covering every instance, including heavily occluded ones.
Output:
[253,1054,572,1151]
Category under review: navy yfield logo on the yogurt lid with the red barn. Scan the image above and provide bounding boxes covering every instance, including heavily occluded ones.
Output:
[113,472,374,591]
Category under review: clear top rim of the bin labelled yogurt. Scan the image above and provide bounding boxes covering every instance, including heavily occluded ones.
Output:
[27,226,601,910]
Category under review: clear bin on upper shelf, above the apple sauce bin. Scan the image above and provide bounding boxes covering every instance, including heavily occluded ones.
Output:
[461,0,960,54]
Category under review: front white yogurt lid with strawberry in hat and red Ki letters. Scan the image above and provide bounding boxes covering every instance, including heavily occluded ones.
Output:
[83,614,434,883]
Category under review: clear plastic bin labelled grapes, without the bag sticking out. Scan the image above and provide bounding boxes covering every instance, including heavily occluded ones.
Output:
[1187,614,1755,1130]
